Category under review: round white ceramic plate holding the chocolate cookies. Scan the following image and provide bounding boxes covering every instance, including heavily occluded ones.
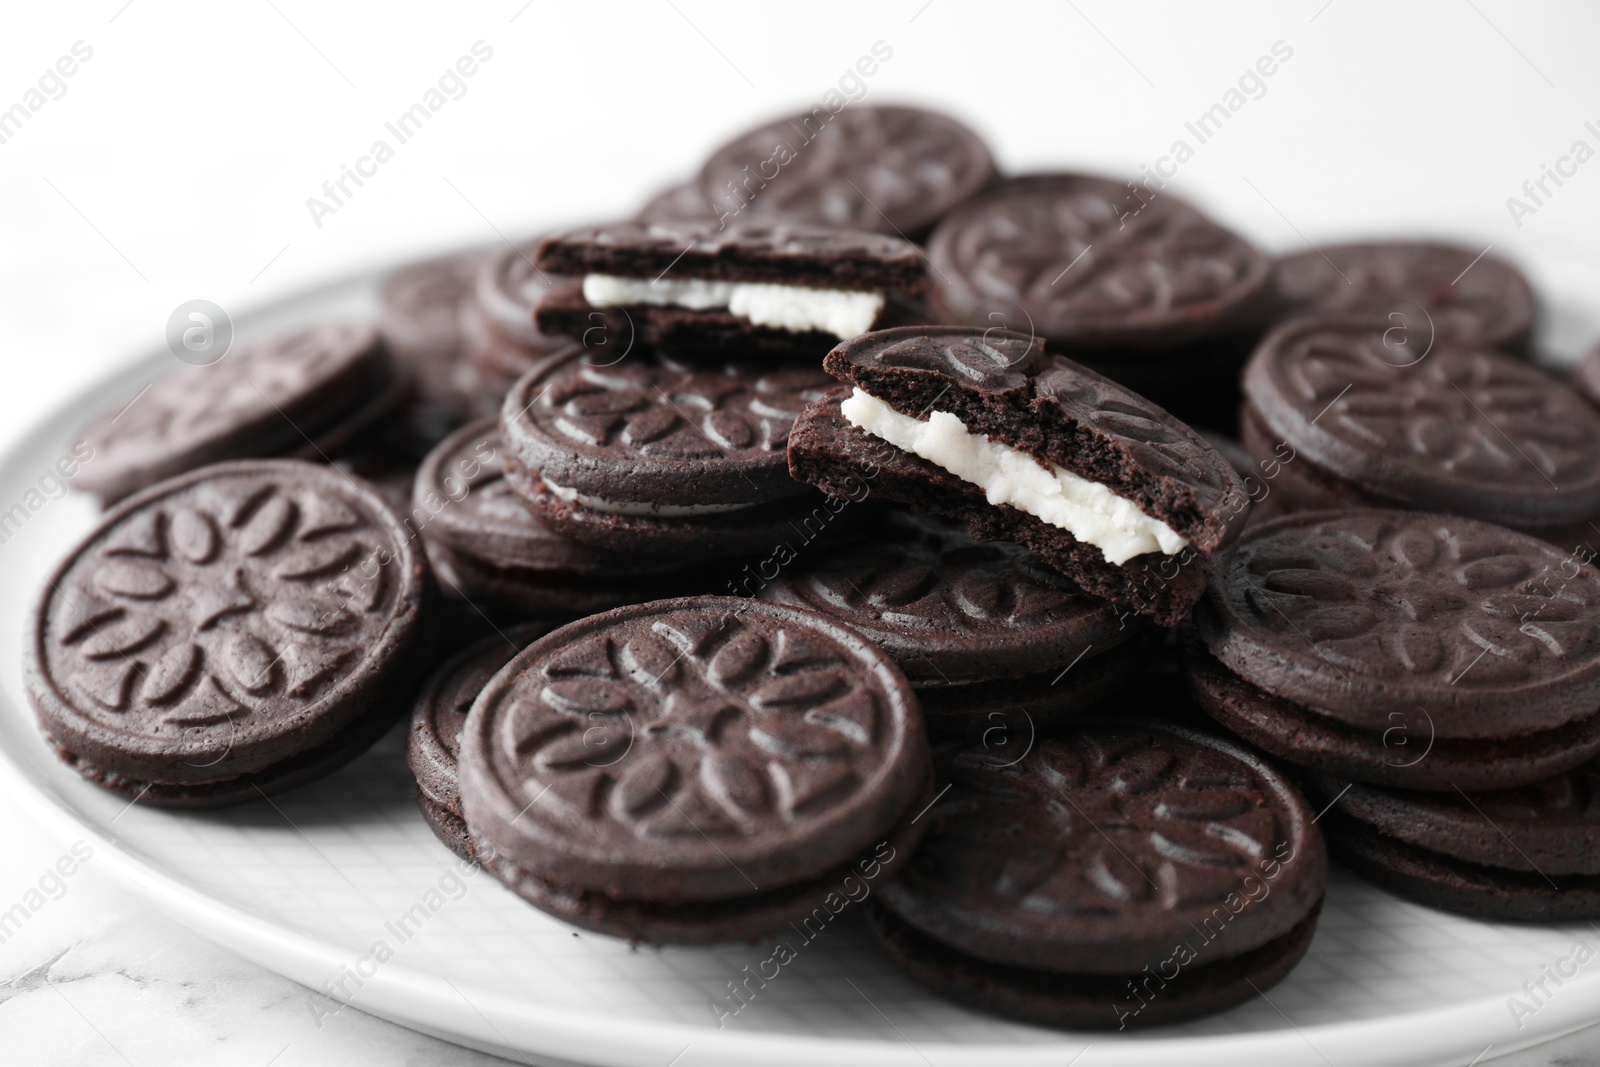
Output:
[0,259,1600,1067]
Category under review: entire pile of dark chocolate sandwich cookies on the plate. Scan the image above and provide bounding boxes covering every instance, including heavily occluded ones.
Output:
[27,106,1600,1029]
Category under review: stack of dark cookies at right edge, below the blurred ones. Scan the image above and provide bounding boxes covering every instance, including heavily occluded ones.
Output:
[1186,509,1600,920]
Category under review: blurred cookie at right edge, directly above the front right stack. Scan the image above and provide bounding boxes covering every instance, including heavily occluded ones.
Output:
[1243,318,1600,549]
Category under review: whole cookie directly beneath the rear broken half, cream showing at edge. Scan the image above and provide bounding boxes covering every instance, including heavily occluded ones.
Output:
[501,352,832,566]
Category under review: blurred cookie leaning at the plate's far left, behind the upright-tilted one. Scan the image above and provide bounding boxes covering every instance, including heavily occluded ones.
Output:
[74,323,410,504]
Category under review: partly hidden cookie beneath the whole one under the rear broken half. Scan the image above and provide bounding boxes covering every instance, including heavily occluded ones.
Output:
[406,418,683,617]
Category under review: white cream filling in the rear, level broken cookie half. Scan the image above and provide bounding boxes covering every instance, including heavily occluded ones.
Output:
[584,274,883,341]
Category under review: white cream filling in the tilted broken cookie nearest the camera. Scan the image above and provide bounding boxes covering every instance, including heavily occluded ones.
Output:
[840,389,1189,565]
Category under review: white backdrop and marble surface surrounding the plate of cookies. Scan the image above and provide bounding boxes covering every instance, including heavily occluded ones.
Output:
[0,0,1600,1067]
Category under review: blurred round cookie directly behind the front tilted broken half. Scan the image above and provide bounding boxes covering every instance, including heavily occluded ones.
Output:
[928,174,1272,355]
